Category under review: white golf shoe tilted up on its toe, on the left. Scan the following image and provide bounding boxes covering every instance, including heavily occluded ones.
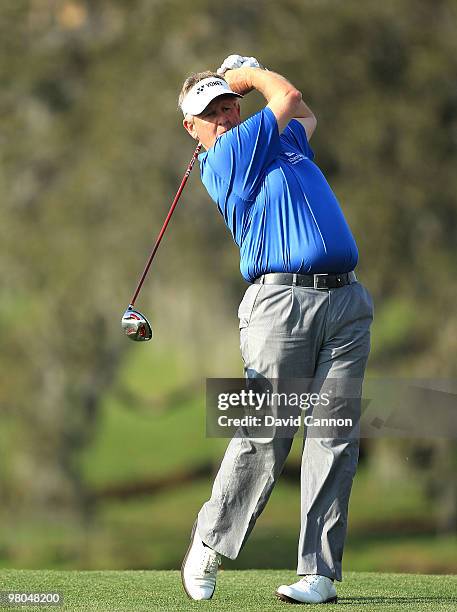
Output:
[181,522,221,600]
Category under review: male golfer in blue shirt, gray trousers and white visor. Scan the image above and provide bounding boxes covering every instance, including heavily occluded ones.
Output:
[179,55,373,603]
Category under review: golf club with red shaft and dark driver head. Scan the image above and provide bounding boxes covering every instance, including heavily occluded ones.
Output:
[121,143,202,342]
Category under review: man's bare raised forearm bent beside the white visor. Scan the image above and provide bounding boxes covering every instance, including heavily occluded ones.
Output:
[224,68,316,140]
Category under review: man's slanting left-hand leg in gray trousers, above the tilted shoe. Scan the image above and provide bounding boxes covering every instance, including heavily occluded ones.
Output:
[198,285,328,559]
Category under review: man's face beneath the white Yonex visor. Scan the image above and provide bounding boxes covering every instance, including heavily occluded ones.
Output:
[183,95,241,149]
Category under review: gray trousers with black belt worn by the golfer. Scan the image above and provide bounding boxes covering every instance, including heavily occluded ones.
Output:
[197,282,373,580]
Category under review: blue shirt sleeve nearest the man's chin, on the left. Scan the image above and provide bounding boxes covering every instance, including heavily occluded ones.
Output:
[201,108,281,201]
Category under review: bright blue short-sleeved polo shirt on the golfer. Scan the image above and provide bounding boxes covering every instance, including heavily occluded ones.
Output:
[199,107,358,282]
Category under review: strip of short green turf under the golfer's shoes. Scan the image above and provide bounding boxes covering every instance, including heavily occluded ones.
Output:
[0,570,457,612]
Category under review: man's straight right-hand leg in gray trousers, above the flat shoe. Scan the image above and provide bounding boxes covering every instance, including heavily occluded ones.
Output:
[297,283,373,580]
